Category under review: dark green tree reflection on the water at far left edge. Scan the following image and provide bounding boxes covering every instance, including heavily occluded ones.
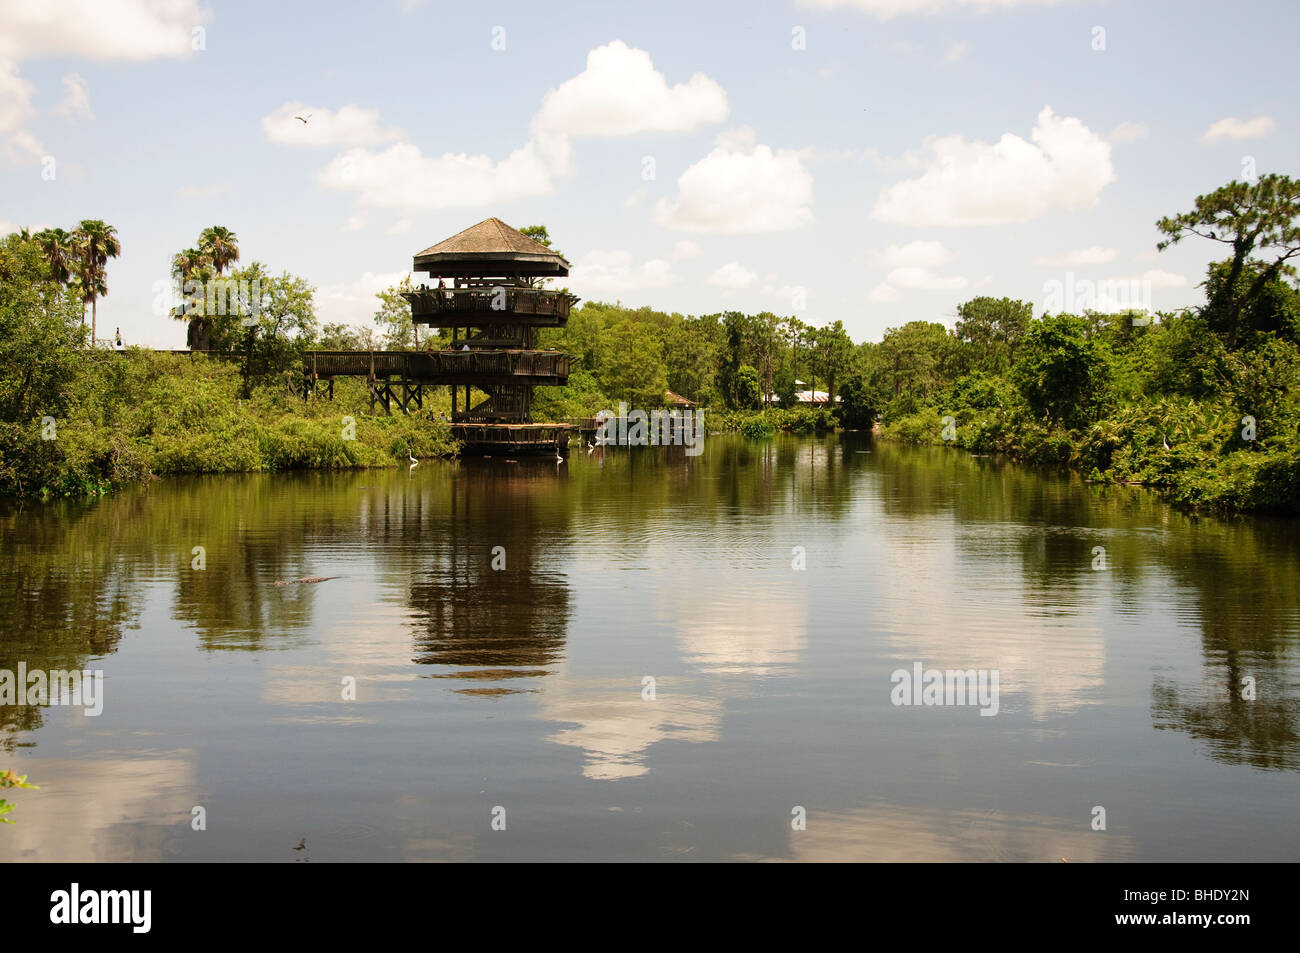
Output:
[0,494,143,750]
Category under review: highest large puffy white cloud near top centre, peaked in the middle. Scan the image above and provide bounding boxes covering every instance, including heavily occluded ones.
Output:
[533,40,727,137]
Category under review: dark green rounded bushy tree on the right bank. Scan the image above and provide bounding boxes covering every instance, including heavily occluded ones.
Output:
[1011,315,1109,428]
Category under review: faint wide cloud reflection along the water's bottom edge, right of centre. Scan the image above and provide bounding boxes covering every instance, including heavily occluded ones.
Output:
[737,803,1134,863]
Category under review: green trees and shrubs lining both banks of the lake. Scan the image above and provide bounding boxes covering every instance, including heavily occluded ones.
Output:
[0,176,1300,512]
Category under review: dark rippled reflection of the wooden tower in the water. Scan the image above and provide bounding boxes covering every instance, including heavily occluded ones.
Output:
[411,462,571,694]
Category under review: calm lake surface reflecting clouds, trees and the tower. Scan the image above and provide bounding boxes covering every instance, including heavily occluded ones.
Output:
[0,434,1300,862]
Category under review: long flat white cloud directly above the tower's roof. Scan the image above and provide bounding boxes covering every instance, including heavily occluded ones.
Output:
[317,142,553,209]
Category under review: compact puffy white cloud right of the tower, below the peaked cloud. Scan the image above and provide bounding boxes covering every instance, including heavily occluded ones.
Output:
[654,130,813,234]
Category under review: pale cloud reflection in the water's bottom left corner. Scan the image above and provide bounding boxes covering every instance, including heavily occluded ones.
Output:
[0,753,202,863]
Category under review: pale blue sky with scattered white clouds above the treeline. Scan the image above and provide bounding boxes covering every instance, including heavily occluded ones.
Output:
[0,0,1300,347]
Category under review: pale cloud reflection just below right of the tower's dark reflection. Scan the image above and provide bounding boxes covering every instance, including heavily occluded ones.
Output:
[540,679,722,781]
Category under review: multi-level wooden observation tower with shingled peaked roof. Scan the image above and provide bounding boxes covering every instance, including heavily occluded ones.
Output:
[403,218,577,451]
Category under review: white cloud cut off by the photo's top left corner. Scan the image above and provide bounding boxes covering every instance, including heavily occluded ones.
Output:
[0,0,209,61]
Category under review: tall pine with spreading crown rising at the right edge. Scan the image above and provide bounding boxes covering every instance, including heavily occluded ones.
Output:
[1156,174,1300,350]
